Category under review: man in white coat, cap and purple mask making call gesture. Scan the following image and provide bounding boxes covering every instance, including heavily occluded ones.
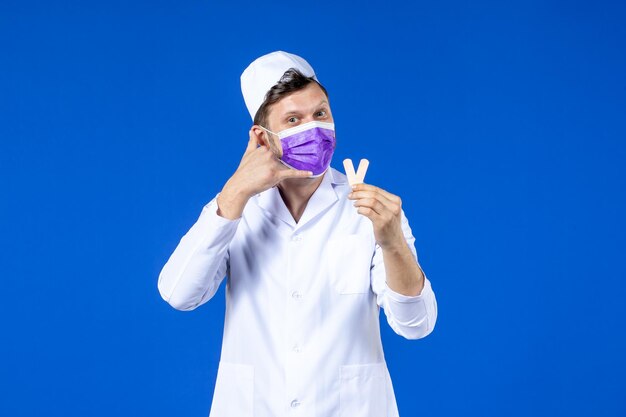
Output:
[158,51,437,417]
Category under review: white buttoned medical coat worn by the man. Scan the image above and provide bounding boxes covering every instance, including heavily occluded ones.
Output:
[158,168,437,417]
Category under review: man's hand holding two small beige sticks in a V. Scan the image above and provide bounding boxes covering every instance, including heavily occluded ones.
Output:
[348,184,406,249]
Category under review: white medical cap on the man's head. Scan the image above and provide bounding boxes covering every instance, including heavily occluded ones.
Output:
[241,51,317,120]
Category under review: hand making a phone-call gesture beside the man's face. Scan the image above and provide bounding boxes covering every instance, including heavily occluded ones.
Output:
[217,126,313,219]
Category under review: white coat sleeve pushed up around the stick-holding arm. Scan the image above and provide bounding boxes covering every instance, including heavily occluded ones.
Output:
[371,211,437,339]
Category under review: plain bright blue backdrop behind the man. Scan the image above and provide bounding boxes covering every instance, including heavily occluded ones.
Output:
[0,0,626,417]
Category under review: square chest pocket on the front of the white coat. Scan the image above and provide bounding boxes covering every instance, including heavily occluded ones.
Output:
[326,234,374,294]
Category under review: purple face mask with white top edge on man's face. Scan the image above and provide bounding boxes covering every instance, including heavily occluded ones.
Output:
[261,122,335,177]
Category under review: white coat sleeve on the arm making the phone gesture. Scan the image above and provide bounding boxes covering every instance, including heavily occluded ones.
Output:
[157,196,241,310]
